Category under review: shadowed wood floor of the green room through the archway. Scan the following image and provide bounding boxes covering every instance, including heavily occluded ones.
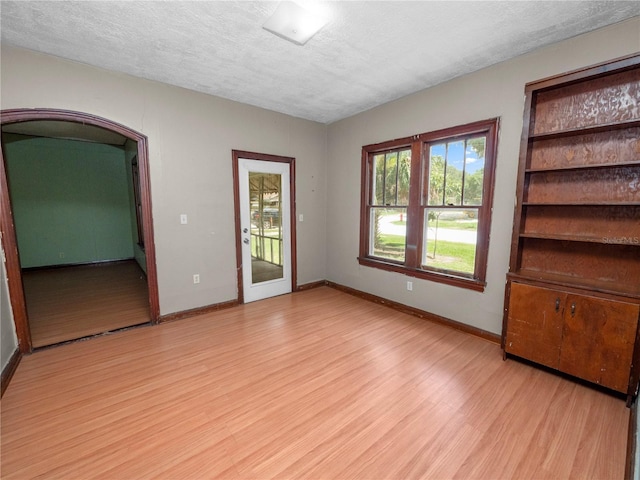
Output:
[22,260,149,347]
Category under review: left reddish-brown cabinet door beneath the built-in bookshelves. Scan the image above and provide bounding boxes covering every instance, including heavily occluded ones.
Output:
[505,283,567,368]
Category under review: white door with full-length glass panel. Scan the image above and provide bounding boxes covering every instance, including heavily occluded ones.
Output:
[238,158,292,302]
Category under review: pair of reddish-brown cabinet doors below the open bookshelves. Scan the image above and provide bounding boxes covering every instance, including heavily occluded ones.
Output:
[505,282,640,393]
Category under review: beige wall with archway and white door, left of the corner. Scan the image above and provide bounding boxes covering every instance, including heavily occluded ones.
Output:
[0,45,327,315]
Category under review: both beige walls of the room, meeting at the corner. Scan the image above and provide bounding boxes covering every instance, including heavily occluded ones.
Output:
[0,18,640,333]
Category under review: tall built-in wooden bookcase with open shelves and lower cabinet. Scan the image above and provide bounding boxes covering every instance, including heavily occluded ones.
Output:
[503,55,640,400]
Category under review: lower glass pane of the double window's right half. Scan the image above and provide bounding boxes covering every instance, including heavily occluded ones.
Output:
[422,208,478,275]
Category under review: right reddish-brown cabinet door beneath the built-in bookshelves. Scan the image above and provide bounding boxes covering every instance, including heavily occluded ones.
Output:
[560,295,640,393]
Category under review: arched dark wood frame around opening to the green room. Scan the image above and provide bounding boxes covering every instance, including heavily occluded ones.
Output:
[0,108,160,353]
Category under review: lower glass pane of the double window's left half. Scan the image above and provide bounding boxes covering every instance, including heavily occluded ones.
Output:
[369,208,407,262]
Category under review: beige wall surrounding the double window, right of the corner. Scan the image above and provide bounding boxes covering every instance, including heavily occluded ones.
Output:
[327,17,640,333]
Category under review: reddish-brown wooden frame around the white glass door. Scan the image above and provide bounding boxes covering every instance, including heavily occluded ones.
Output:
[231,150,298,303]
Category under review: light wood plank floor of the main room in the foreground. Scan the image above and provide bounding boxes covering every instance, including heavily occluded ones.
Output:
[1,287,629,479]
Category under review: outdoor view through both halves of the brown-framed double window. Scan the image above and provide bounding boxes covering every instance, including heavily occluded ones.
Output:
[371,137,486,274]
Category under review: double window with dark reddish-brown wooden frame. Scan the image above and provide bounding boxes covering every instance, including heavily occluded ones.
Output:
[359,119,498,291]
